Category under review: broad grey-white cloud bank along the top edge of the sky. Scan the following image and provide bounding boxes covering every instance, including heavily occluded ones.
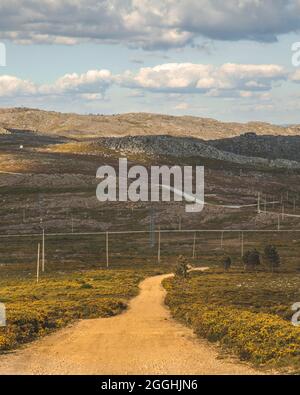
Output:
[0,0,300,49]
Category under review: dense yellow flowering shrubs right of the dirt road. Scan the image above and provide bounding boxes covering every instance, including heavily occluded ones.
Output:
[164,274,300,368]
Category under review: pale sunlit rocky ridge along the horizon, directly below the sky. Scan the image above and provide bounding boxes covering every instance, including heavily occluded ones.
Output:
[0,108,300,140]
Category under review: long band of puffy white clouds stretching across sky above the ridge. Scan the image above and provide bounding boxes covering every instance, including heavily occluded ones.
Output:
[0,63,290,102]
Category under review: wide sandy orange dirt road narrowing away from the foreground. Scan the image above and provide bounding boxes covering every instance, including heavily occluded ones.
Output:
[0,276,256,374]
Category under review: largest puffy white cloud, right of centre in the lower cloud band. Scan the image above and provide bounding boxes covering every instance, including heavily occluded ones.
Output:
[118,63,288,96]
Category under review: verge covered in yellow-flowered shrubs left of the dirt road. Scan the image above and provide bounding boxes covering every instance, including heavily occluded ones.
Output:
[0,270,161,352]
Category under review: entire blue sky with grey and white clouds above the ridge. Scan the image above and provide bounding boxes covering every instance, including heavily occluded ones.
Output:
[0,0,300,124]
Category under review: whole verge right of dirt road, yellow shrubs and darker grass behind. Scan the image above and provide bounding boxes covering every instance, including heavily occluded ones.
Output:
[164,270,300,371]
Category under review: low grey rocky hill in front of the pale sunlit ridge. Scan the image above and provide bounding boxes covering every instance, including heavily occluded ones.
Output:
[59,135,300,169]
